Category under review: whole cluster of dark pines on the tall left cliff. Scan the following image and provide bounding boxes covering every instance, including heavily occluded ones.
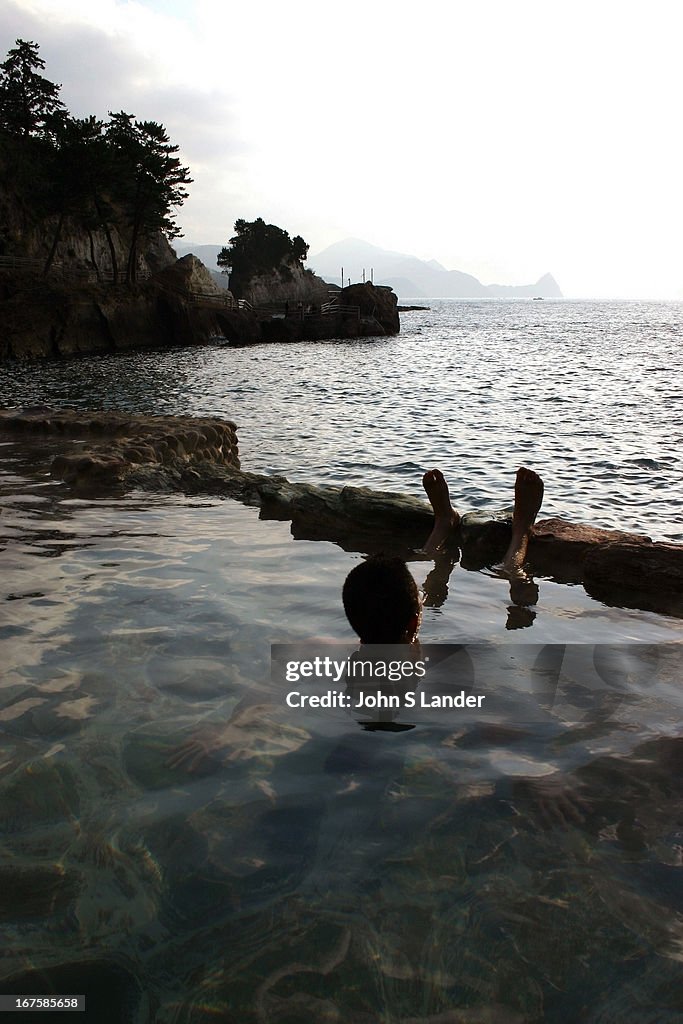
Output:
[0,39,191,282]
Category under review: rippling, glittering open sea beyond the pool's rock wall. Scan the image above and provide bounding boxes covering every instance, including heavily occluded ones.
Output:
[0,300,683,539]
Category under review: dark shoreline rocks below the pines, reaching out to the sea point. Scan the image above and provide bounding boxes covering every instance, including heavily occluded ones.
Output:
[0,254,399,364]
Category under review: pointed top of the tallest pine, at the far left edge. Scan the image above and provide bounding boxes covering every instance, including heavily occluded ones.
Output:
[0,39,66,136]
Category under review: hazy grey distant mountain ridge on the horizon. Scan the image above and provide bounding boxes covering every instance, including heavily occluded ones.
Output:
[308,239,562,299]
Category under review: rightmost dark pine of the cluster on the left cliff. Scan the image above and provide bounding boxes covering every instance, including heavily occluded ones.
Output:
[105,111,193,282]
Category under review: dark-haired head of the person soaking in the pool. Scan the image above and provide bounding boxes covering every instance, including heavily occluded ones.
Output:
[342,555,422,643]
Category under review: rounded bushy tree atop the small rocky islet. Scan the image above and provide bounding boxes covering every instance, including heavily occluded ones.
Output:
[217,217,308,294]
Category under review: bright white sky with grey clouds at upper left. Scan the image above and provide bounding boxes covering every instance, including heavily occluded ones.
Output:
[0,0,683,299]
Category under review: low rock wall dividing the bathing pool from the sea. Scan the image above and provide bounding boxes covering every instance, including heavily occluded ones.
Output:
[0,408,683,616]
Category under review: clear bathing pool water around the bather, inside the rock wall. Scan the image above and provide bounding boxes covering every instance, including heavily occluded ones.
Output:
[0,468,683,1024]
